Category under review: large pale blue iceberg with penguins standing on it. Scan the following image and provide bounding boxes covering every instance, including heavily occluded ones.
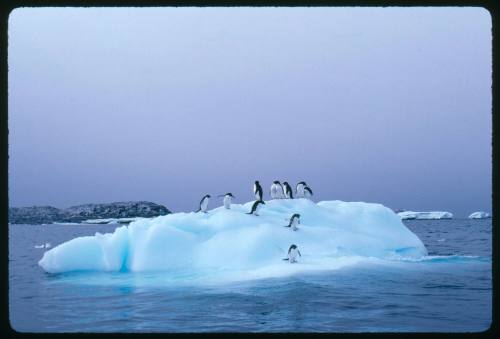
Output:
[38,199,427,273]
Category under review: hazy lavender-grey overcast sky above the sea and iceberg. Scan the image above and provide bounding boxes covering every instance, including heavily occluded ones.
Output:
[8,7,492,217]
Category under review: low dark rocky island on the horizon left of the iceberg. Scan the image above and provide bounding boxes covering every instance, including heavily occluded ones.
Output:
[9,201,171,225]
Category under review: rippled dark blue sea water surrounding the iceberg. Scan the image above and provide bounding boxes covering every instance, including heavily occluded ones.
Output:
[9,219,492,332]
